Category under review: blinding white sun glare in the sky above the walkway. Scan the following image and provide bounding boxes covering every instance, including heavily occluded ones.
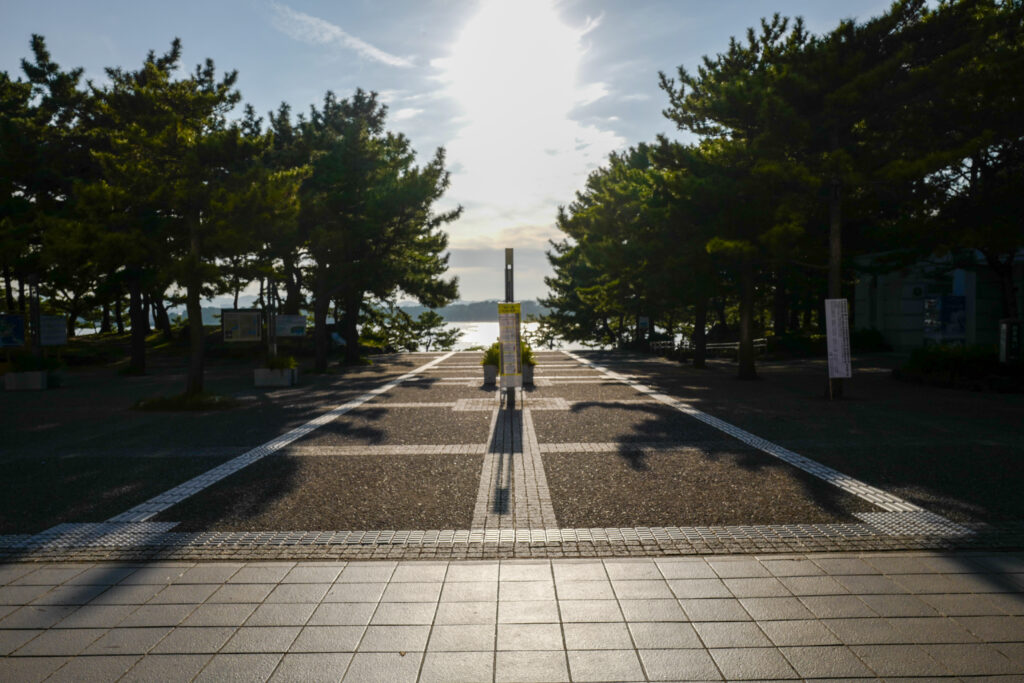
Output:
[435,0,621,219]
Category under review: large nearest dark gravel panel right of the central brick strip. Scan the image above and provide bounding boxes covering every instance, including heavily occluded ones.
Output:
[544,449,876,527]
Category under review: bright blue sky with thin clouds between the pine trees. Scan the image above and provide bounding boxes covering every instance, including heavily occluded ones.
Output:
[0,0,890,300]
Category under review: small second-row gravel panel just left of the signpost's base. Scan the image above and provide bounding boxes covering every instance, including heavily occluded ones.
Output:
[295,409,490,445]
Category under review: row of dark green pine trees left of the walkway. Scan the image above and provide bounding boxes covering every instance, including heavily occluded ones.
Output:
[0,36,461,394]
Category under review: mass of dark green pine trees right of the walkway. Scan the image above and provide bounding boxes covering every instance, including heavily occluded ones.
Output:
[541,0,1024,378]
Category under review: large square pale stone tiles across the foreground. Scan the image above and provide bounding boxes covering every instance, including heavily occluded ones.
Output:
[0,552,1024,682]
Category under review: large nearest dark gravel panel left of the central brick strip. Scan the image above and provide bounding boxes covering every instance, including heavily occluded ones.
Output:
[158,455,483,531]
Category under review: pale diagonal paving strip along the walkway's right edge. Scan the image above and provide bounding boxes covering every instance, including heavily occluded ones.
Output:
[562,351,942,513]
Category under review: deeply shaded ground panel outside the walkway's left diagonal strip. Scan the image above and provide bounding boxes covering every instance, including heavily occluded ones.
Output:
[0,457,227,533]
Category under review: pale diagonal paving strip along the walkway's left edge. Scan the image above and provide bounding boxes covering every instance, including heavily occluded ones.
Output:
[106,351,455,522]
